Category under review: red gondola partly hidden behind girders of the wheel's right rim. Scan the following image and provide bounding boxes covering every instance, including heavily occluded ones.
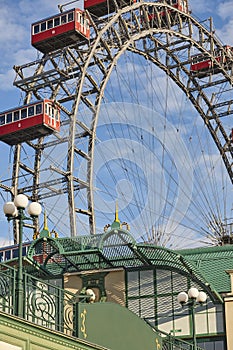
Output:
[190,45,233,78]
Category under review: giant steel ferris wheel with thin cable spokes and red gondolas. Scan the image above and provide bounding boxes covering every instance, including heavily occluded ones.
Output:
[0,0,233,248]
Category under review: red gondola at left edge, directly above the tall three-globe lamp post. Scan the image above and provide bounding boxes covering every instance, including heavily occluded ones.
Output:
[0,100,60,145]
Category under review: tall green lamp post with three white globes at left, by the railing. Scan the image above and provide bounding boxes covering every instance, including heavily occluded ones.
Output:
[3,194,42,317]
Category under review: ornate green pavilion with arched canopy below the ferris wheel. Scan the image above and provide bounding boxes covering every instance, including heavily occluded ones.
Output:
[0,216,233,350]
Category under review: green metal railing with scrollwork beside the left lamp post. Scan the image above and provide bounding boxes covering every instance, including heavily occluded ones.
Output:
[0,264,79,336]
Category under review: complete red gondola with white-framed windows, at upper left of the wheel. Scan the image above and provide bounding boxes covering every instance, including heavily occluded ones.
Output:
[31,9,90,53]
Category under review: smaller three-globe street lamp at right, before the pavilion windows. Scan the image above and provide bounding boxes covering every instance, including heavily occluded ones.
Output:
[177,287,207,350]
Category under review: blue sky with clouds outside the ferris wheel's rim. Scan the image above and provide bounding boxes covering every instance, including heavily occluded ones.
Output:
[0,0,233,246]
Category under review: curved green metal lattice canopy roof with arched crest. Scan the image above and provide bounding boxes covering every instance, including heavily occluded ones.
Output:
[24,228,226,300]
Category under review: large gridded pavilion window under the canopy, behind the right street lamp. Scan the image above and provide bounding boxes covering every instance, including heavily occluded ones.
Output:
[126,268,224,340]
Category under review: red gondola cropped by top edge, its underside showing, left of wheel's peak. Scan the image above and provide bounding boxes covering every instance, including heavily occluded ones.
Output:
[84,0,137,17]
